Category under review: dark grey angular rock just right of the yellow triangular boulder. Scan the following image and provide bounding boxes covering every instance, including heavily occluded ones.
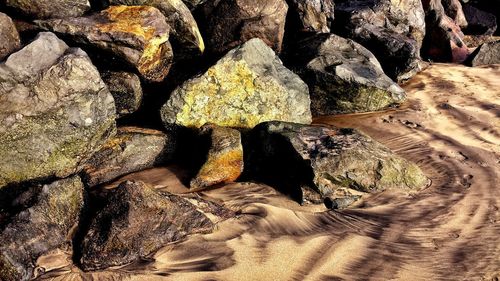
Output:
[296,34,406,115]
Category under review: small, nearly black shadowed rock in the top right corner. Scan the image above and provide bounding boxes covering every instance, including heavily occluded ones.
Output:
[463,4,497,35]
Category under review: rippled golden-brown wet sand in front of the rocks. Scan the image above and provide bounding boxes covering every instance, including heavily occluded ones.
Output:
[40,64,500,280]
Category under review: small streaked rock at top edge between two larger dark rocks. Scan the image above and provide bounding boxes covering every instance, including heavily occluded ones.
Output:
[288,0,335,33]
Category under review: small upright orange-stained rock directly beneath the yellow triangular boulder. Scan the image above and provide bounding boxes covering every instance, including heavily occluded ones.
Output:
[190,125,243,190]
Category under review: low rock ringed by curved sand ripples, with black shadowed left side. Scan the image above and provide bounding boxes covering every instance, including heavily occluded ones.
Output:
[246,122,428,207]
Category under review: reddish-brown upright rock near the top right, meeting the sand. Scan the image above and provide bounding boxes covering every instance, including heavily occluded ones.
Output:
[422,0,469,62]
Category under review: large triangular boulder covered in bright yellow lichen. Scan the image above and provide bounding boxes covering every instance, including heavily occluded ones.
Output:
[161,39,311,128]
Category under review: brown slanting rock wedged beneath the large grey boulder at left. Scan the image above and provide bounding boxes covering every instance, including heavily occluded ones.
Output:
[83,127,175,186]
